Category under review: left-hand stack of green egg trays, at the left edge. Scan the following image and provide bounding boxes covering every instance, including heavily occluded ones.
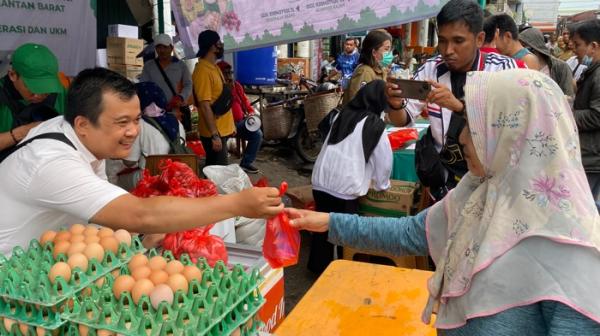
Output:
[0,237,145,330]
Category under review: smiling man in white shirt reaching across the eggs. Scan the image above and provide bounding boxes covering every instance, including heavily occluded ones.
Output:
[0,68,283,254]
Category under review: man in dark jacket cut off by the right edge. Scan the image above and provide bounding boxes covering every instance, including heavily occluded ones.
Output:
[572,20,600,201]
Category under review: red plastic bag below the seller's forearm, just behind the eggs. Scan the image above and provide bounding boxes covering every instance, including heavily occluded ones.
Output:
[163,225,228,267]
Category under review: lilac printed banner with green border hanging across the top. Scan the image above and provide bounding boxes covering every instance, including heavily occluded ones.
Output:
[171,0,447,56]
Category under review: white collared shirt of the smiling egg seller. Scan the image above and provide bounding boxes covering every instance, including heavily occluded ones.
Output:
[0,116,127,255]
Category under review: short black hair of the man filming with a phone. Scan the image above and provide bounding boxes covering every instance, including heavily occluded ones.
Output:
[436,0,483,35]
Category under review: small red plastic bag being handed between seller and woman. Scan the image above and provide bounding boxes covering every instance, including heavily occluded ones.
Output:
[263,182,300,268]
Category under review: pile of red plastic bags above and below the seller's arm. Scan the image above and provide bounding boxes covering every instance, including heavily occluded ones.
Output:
[131,160,227,266]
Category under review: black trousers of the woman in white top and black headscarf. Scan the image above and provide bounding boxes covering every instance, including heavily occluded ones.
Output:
[308,190,358,274]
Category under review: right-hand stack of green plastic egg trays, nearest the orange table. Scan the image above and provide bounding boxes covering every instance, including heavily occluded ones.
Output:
[62,250,264,336]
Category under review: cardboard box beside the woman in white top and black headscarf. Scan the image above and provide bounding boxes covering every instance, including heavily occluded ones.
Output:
[359,180,417,217]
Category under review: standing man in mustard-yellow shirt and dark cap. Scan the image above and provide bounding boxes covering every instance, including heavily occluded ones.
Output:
[192,30,235,166]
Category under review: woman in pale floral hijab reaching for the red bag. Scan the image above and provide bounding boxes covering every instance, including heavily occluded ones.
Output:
[289,70,600,335]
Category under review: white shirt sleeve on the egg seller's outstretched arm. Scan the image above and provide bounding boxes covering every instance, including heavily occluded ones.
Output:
[28,155,127,221]
